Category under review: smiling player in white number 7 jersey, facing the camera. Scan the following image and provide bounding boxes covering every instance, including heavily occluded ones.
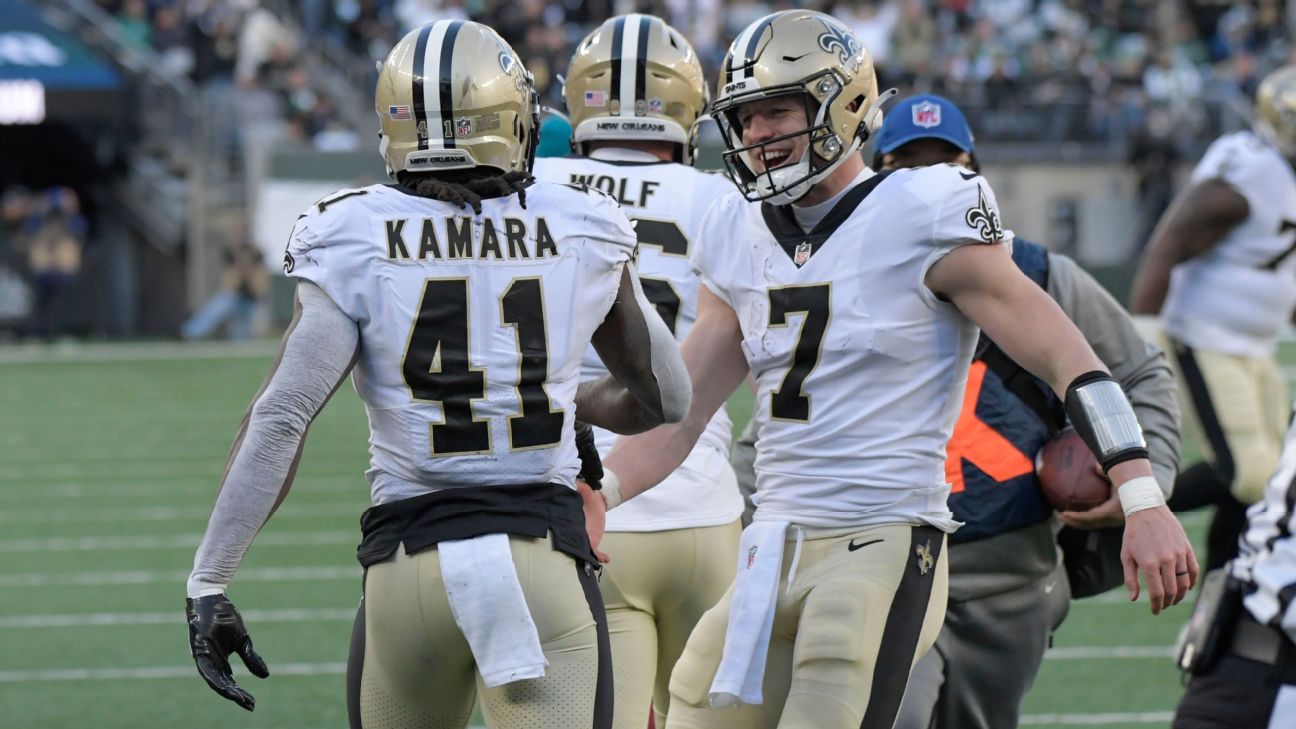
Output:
[587,10,1196,729]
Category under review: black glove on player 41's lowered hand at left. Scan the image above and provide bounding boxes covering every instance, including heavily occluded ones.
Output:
[184,595,270,711]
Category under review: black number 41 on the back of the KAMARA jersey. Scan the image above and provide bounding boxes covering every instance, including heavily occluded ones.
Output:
[400,279,562,455]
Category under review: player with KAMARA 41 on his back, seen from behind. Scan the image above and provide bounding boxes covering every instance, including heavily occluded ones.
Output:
[188,21,689,729]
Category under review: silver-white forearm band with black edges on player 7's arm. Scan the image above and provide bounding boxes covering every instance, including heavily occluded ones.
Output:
[1067,370,1147,471]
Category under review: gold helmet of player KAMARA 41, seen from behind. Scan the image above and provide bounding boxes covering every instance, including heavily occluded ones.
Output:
[373,21,540,176]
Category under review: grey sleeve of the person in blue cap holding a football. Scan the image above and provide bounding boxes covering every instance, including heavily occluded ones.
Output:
[1048,253,1179,496]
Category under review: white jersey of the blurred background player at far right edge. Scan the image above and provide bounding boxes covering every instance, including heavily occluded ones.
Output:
[1161,131,1296,357]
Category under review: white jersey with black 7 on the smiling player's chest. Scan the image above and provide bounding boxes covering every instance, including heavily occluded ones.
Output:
[693,165,1006,532]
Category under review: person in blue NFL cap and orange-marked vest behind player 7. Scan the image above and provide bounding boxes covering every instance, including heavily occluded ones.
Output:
[855,95,1179,729]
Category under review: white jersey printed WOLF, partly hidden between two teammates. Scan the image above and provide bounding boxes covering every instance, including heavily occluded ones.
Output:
[535,148,743,532]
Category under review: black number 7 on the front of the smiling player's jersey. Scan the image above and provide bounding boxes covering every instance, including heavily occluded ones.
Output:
[770,284,832,423]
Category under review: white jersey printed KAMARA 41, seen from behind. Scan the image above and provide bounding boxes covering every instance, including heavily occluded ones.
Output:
[284,183,635,503]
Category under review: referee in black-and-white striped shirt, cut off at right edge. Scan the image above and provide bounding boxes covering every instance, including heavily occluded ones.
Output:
[1174,396,1296,729]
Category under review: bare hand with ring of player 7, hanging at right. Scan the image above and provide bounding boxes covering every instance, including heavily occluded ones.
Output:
[1121,506,1198,615]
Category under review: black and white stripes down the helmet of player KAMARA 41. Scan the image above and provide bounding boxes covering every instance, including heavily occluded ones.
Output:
[411,21,464,149]
